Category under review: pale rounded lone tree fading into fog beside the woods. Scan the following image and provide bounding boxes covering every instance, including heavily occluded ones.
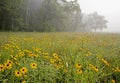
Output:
[82,12,108,32]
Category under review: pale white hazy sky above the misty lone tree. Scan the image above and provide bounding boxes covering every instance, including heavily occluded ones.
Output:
[78,0,120,32]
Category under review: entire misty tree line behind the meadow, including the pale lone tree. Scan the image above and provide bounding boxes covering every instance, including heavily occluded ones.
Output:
[0,0,107,32]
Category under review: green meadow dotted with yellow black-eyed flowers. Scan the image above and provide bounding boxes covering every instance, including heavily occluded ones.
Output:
[0,32,120,83]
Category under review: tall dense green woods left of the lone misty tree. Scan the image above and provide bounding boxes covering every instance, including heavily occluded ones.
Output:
[0,0,81,32]
